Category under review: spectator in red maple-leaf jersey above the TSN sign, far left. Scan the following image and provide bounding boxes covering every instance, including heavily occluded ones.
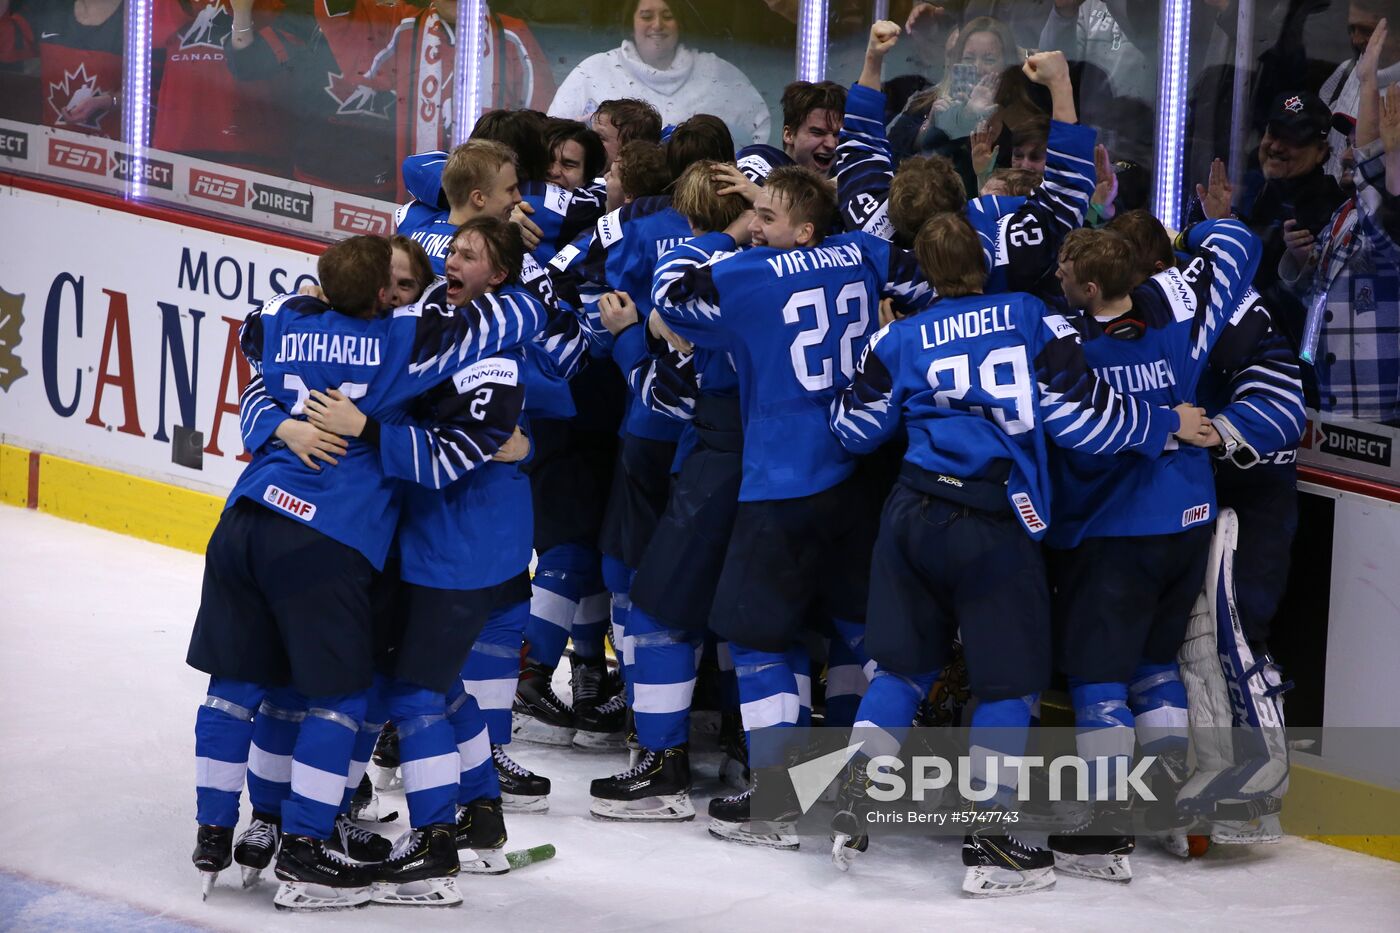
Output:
[25,0,126,139]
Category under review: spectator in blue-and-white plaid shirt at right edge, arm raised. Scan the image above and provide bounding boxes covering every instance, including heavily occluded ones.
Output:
[1282,20,1400,426]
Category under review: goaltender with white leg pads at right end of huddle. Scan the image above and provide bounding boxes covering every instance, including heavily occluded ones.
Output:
[1109,207,1306,857]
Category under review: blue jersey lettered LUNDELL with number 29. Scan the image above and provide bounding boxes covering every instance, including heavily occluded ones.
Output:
[830,293,1179,539]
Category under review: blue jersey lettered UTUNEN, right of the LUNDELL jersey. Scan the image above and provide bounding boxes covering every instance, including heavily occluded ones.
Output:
[1049,219,1260,548]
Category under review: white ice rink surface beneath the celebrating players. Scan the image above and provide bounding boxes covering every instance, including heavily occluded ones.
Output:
[0,506,1400,933]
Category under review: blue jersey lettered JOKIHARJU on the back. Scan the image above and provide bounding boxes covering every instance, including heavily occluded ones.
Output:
[228,286,545,567]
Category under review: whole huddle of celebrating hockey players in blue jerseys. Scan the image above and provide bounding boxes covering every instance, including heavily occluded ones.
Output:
[188,22,1303,909]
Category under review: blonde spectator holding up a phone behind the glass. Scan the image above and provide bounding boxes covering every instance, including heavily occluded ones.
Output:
[932,17,1022,140]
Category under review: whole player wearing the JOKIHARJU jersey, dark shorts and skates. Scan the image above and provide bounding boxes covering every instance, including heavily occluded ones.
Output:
[186,237,543,906]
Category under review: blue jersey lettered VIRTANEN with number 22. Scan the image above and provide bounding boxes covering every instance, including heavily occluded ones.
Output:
[652,231,930,502]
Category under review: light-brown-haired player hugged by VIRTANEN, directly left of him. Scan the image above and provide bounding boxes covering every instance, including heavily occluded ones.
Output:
[589,161,746,821]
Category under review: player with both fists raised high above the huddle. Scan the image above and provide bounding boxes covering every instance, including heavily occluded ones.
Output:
[834,22,1096,298]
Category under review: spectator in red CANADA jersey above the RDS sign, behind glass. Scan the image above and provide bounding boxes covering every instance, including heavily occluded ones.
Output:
[151,0,291,177]
